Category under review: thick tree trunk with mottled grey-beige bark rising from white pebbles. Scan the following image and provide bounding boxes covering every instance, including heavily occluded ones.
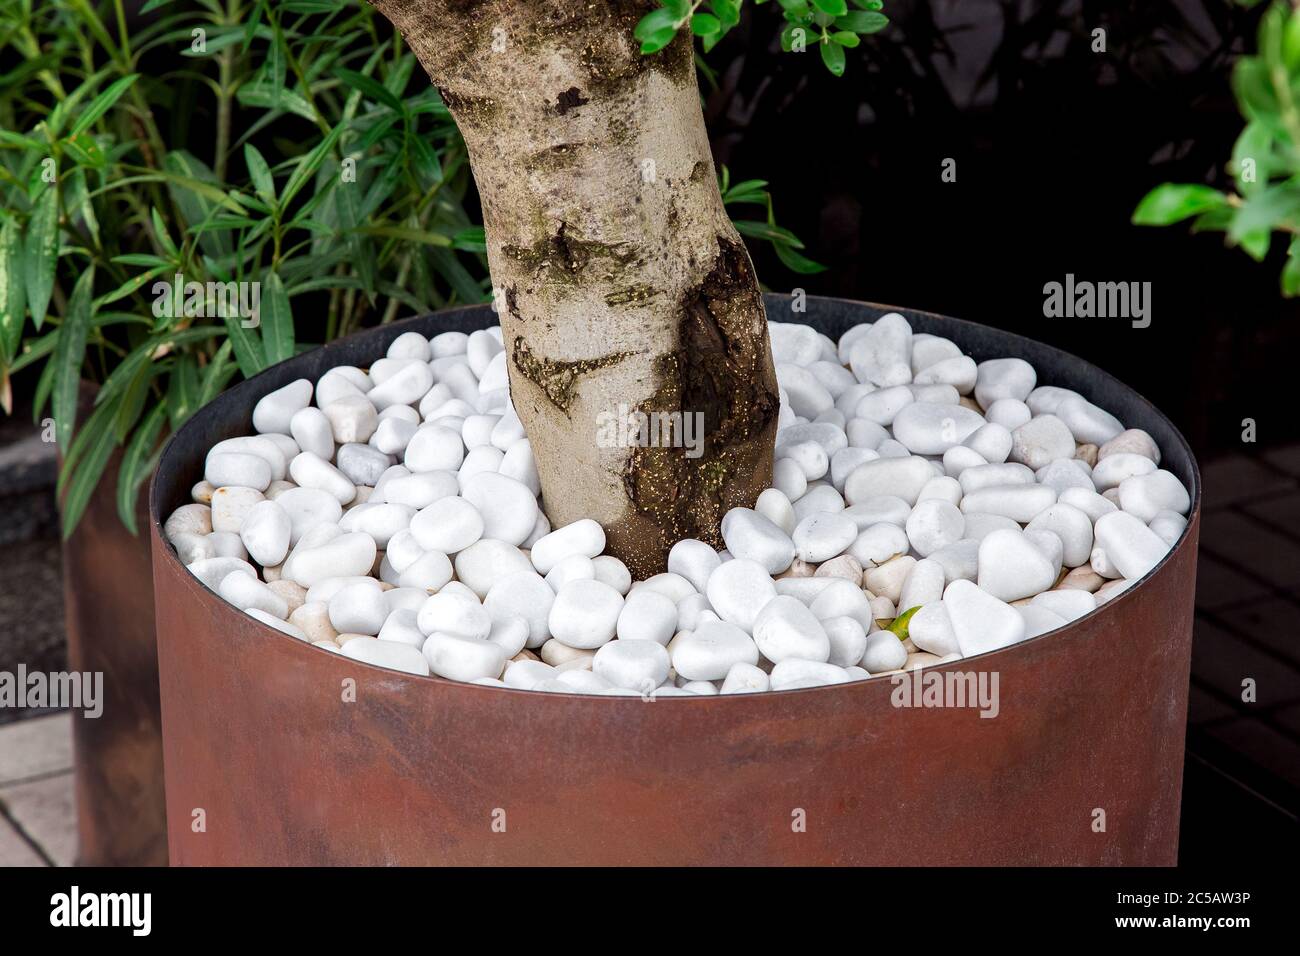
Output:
[372,0,779,578]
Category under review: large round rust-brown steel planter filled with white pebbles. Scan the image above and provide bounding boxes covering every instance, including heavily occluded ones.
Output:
[150,297,1200,865]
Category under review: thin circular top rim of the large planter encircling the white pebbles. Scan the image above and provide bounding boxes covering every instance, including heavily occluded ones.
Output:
[148,293,1203,706]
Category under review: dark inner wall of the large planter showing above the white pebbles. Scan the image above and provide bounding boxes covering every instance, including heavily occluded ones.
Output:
[150,293,1201,701]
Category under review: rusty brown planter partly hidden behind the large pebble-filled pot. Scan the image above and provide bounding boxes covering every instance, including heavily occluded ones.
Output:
[62,389,168,866]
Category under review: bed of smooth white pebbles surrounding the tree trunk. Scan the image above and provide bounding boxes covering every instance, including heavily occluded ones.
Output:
[165,313,1190,696]
